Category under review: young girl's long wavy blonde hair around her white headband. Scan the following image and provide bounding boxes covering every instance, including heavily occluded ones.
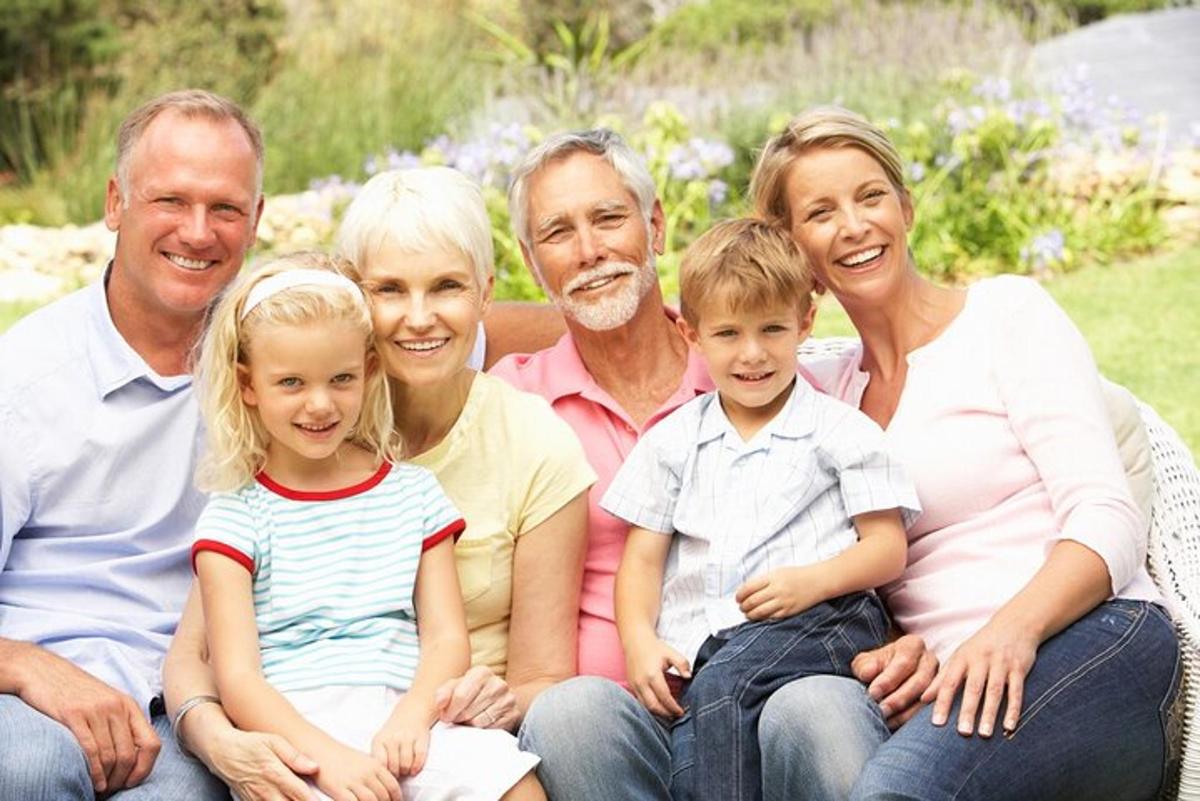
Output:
[194,253,400,492]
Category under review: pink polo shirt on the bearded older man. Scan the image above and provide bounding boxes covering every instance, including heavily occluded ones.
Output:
[491,312,713,683]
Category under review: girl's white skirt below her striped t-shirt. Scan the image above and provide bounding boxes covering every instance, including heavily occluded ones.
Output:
[232,686,540,801]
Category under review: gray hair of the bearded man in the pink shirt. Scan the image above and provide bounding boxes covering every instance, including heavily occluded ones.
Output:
[509,128,656,248]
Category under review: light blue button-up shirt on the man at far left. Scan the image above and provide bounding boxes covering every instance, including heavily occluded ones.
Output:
[0,275,204,707]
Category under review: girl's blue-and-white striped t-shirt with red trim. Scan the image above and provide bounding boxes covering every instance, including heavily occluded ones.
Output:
[192,463,466,691]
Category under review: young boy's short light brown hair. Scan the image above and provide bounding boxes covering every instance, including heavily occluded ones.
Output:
[679,218,815,327]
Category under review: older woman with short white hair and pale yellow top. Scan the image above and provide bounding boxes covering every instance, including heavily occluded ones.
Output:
[336,167,595,730]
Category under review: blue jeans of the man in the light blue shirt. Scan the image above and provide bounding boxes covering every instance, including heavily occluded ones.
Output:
[0,694,229,801]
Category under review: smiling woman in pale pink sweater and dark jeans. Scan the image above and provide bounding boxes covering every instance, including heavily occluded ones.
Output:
[751,108,1180,801]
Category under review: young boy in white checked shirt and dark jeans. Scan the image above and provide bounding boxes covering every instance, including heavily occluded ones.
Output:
[600,219,919,801]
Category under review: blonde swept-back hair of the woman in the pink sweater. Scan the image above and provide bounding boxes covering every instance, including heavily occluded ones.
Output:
[750,106,908,229]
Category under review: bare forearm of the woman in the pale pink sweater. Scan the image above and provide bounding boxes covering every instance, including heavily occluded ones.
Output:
[992,540,1112,643]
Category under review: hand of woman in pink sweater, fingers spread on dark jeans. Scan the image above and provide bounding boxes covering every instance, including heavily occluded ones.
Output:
[920,616,1039,737]
